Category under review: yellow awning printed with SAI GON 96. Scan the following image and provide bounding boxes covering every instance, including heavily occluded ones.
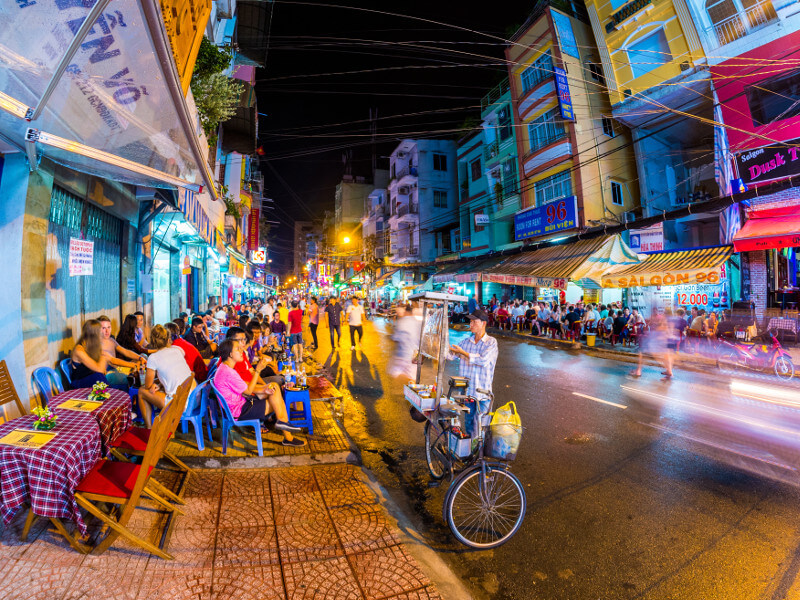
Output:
[602,246,733,288]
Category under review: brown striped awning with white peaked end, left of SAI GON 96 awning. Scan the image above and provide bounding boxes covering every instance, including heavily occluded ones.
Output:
[484,235,640,290]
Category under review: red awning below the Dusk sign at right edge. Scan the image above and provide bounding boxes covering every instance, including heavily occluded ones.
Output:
[733,206,800,252]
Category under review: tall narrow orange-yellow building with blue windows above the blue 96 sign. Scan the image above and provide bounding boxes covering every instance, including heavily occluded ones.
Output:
[506,1,639,246]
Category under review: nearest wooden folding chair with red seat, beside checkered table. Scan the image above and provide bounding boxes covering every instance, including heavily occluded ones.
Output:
[75,378,191,560]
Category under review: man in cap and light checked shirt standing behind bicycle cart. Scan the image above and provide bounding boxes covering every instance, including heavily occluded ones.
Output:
[447,308,497,437]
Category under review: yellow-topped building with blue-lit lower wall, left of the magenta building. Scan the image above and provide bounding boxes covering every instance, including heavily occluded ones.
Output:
[586,0,712,249]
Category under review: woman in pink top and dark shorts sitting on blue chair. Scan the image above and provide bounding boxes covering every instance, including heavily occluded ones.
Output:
[214,339,305,446]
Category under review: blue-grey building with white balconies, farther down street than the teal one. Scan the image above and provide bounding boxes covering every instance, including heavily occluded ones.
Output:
[389,140,459,264]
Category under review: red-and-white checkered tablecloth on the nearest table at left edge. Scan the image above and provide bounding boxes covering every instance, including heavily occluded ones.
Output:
[0,410,100,534]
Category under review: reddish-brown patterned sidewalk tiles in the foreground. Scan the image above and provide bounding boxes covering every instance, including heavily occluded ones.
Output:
[0,464,440,600]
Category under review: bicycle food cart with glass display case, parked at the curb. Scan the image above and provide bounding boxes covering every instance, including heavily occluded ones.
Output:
[403,292,526,549]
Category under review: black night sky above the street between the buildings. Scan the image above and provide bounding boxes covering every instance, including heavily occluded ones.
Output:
[256,0,533,272]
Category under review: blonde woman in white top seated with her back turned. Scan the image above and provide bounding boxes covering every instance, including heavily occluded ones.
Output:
[139,325,194,428]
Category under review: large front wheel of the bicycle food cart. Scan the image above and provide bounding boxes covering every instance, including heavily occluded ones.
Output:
[444,464,525,549]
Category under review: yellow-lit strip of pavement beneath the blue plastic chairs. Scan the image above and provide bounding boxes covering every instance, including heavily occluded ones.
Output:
[169,402,350,459]
